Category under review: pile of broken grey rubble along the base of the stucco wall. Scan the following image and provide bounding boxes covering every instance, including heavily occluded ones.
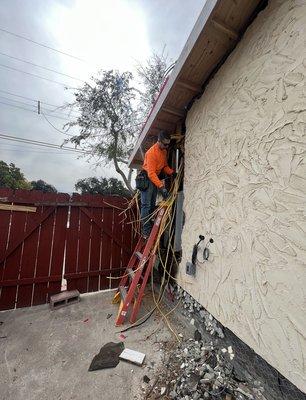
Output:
[143,290,265,400]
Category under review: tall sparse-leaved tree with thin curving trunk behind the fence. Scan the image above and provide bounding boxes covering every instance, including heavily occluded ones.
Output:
[67,70,137,192]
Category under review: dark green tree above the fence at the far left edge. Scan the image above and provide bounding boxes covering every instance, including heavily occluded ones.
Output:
[0,161,31,189]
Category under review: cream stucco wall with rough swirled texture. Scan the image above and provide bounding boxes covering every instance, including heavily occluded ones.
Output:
[179,0,306,392]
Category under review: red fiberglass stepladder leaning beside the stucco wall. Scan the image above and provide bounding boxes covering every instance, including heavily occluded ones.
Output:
[113,207,165,326]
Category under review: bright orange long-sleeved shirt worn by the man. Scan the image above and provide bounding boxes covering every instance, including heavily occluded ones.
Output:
[142,143,174,188]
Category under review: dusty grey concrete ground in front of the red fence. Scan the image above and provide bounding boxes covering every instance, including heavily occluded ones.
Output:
[0,292,182,400]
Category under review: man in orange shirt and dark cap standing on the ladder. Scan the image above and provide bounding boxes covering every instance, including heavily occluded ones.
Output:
[140,131,174,239]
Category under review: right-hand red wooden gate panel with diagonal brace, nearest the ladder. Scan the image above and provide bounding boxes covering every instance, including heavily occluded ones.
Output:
[65,195,135,293]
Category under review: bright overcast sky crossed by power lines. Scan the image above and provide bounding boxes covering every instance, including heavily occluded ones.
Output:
[0,0,205,192]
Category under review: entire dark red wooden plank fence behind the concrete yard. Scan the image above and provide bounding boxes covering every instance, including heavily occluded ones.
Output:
[0,189,135,310]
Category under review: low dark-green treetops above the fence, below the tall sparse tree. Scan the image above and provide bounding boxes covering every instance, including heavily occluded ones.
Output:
[75,177,130,197]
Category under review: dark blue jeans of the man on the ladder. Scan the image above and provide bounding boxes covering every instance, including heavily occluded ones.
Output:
[140,180,157,236]
